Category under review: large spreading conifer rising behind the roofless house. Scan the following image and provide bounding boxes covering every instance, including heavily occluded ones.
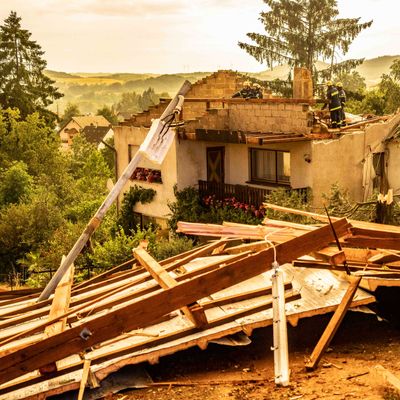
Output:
[238,0,372,83]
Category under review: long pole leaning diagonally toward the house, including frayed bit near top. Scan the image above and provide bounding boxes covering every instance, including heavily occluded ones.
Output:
[37,81,191,301]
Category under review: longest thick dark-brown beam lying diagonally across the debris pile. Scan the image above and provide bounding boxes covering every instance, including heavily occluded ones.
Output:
[0,219,348,384]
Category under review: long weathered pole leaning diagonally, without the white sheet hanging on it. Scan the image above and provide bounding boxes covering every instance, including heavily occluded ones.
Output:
[37,81,191,301]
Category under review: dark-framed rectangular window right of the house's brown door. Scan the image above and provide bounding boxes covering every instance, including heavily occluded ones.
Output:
[250,149,290,185]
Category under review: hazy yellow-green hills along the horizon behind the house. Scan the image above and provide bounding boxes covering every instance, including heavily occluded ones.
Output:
[46,55,400,114]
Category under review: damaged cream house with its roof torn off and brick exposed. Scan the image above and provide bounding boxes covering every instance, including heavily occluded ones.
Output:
[114,68,400,225]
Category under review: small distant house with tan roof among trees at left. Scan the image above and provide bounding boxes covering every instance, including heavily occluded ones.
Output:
[58,115,112,150]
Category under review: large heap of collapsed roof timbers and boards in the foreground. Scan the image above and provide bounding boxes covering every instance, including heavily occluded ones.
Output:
[0,211,400,399]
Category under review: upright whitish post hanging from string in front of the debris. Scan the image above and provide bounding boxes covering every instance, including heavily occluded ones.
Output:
[271,261,290,386]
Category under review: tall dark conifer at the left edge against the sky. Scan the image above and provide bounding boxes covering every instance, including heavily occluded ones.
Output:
[0,11,62,119]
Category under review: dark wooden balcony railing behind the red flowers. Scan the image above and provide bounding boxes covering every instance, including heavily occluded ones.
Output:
[199,181,309,207]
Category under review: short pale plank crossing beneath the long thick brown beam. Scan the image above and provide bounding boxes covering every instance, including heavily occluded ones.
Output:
[133,247,207,328]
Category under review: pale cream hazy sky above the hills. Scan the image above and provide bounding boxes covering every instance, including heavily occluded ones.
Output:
[0,0,400,73]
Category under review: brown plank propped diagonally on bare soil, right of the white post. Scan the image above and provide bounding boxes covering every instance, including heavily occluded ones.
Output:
[306,277,361,370]
